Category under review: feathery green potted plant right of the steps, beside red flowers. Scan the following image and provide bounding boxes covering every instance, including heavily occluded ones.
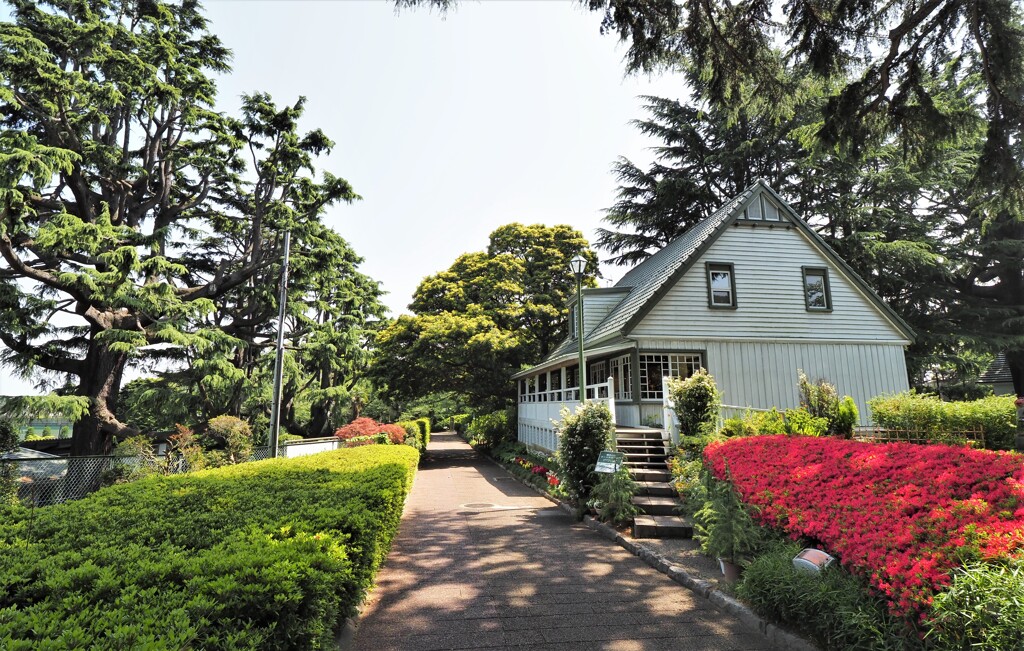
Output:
[694,471,764,582]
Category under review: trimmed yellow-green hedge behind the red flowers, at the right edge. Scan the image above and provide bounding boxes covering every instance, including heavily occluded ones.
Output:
[867,392,1017,449]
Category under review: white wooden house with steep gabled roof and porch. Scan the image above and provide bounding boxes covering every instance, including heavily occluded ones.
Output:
[515,181,914,449]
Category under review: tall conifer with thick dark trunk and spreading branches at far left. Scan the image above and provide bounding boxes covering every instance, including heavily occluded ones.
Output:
[0,0,366,454]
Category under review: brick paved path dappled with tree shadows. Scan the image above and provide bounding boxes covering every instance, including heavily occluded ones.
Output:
[354,434,769,651]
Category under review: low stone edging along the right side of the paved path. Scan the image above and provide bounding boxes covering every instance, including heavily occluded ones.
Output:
[499,455,820,651]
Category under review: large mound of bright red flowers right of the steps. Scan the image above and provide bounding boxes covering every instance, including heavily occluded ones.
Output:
[705,436,1024,619]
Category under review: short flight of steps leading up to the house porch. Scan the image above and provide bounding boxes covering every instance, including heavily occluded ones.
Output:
[615,427,693,538]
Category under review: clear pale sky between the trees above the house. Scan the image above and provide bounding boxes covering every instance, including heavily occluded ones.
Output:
[0,0,685,394]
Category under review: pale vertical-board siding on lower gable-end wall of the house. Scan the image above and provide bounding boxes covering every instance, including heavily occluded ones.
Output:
[639,339,909,425]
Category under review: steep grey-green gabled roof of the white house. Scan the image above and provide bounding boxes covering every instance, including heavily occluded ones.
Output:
[519,179,915,375]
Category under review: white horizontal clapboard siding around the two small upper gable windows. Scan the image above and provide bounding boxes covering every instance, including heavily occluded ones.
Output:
[630,221,909,344]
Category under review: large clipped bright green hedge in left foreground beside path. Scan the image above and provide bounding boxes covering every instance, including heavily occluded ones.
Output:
[0,445,419,651]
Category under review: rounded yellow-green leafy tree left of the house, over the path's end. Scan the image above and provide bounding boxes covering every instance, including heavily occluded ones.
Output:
[373,223,597,411]
